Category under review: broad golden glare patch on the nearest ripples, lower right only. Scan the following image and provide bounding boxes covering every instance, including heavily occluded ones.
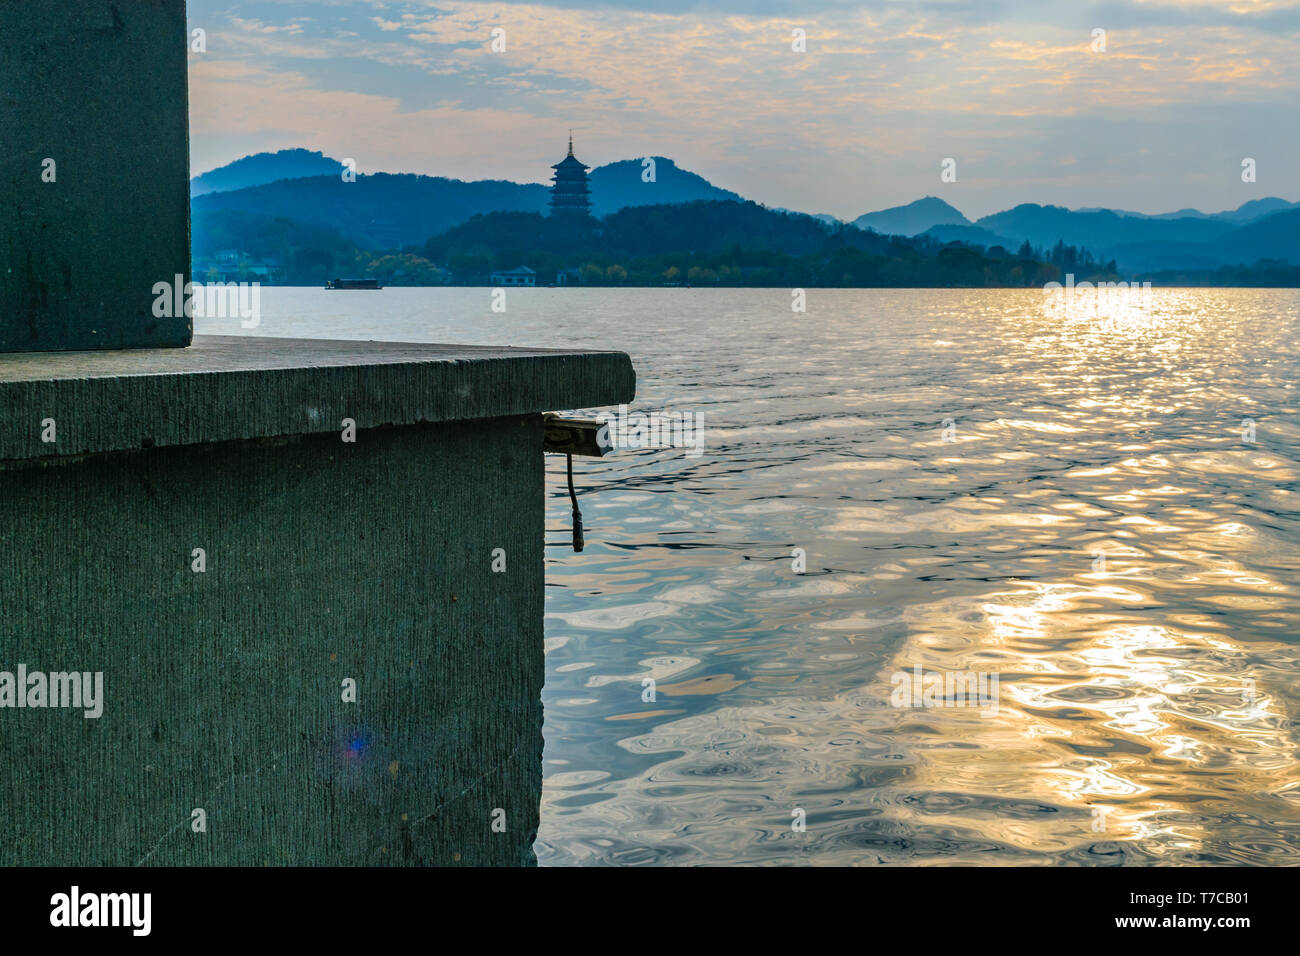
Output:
[889,574,1300,852]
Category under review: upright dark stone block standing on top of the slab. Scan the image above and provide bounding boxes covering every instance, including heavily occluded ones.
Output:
[0,0,191,352]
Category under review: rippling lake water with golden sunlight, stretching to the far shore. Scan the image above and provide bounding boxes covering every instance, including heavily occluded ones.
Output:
[196,289,1300,865]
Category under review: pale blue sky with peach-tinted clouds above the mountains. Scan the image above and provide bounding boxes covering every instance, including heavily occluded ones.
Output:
[189,0,1300,219]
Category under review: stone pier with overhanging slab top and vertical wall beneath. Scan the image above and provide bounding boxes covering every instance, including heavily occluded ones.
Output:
[0,336,634,865]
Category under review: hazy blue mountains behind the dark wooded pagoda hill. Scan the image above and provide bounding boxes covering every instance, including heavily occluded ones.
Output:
[191,150,1300,274]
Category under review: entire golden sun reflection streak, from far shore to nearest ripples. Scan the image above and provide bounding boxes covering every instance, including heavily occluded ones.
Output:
[850,290,1300,858]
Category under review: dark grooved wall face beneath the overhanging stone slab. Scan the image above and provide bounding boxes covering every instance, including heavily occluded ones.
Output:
[0,416,543,865]
